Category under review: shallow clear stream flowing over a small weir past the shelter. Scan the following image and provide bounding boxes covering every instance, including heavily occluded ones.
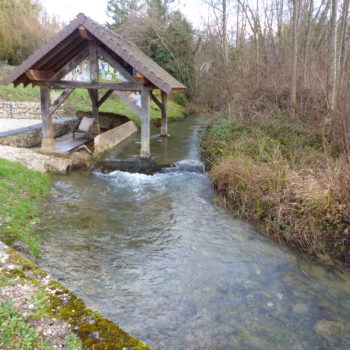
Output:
[38,118,350,350]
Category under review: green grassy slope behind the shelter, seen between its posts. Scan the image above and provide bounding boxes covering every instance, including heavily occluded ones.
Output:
[0,65,186,124]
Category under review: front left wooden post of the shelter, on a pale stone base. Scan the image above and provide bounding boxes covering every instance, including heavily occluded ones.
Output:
[40,86,56,152]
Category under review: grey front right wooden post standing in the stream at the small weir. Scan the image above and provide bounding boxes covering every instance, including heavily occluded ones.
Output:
[140,88,151,158]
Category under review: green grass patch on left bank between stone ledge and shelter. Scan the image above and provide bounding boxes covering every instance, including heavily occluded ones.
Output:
[0,159,51,256]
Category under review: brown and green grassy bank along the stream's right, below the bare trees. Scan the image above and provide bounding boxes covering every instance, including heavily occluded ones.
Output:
[201,98,350,263]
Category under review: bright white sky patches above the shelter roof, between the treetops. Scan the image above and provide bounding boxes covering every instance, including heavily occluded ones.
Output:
[41,0,207,28]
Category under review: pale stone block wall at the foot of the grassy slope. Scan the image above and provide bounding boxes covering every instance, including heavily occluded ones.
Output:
[0,101,64,119]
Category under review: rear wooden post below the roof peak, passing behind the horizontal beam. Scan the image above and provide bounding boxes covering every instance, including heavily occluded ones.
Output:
[89,41,101,135]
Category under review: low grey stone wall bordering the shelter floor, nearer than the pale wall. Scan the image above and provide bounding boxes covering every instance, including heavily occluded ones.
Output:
[0,117,79,147]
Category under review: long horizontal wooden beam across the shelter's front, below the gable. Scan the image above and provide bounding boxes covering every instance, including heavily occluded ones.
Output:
[38,80,144,91]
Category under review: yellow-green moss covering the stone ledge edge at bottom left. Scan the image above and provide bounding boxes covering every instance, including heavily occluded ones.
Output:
[0,248,150,350]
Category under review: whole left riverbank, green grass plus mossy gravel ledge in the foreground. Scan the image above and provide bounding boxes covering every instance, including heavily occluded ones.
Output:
[0,159,149,350]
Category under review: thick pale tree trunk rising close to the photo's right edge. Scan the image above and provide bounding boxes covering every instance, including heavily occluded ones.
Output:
[328,0,338,111]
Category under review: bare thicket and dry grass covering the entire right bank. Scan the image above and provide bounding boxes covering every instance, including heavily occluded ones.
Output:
[196,0,350,263]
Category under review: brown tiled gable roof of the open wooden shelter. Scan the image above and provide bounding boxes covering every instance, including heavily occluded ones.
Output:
[0,13,186,94]
